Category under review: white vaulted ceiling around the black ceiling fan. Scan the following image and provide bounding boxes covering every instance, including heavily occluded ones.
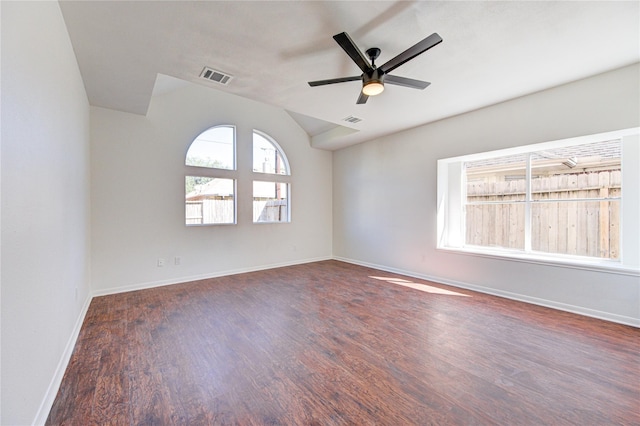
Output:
[60,1,640,149]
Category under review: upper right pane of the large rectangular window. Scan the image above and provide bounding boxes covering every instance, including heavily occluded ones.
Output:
[531,140,621,200]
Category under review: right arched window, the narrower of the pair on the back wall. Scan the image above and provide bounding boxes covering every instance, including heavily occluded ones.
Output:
[253,130,291,223]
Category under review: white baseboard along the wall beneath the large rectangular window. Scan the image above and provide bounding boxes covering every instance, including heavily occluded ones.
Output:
[333,256,640,328]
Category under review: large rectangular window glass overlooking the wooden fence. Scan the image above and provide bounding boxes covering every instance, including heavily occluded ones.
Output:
[464,139,622,259]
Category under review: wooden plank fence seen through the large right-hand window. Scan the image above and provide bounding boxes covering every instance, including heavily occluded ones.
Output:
[466,170,621,259]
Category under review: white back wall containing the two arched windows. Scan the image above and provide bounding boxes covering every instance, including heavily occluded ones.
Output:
[91,80,332,294]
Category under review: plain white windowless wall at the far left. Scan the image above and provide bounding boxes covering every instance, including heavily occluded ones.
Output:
[0,2,90,425]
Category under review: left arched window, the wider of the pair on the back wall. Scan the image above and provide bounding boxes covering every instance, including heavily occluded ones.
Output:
[185,125,236,225]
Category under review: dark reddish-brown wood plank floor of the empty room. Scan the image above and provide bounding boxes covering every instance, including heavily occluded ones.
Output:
[47,261,640,425]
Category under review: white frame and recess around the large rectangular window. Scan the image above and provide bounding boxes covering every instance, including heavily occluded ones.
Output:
[436,128,640,276]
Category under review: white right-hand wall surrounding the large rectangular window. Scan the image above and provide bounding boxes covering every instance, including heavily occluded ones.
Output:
[333,64,640,326]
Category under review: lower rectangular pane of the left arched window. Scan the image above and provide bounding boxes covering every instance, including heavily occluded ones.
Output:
[185,176,235,225]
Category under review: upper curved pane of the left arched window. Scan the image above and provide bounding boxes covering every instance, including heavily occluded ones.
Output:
[185,126,235,170]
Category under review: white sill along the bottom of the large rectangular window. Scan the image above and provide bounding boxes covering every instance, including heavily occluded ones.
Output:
[437,247,640,277]
